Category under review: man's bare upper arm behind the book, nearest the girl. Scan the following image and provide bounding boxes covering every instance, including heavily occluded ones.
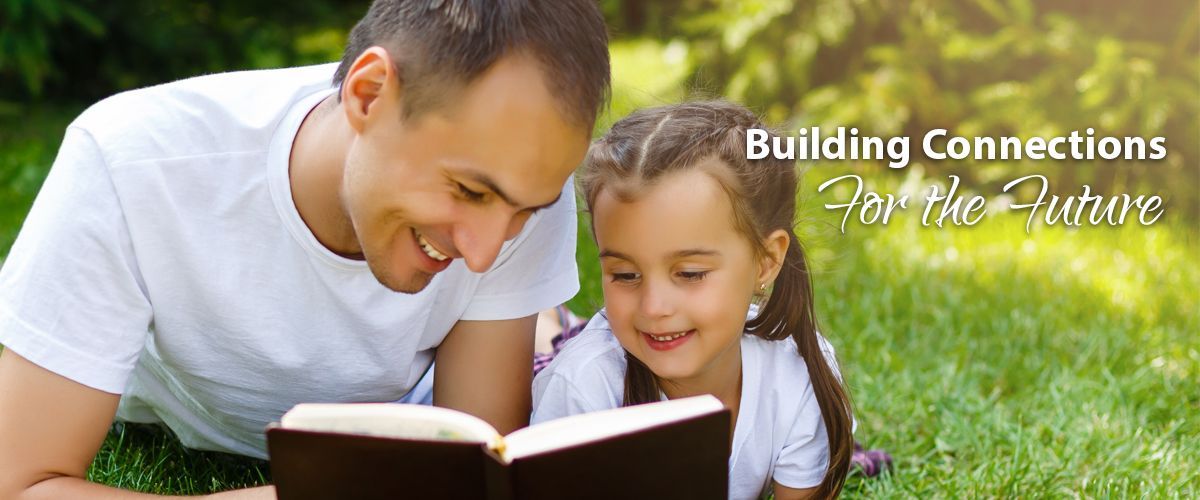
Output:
[433,315,538,434]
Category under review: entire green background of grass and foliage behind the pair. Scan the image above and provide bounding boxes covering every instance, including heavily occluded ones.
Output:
[0,0,1200,498]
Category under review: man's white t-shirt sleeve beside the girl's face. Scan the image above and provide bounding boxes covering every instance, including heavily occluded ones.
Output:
[461,177,580,320]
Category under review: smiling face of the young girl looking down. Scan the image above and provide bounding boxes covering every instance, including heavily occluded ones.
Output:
[593,168,775,384]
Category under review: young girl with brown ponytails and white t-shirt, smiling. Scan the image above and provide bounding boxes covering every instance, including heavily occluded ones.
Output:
[532,102,853,499]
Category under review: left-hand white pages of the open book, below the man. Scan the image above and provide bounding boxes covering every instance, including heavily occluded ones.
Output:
[280,403,503,448]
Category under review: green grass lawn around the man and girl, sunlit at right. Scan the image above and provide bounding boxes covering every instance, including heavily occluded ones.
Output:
[0,99,1200,498]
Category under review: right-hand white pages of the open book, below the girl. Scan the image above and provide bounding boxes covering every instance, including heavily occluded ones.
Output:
[503,396,725,462]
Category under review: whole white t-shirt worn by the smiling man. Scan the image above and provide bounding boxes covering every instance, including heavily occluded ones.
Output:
[0,65,578,457]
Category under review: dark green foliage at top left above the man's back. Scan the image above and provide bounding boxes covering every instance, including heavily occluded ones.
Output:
[0,0,367,100]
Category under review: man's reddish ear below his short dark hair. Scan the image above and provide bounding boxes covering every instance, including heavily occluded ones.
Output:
[342,46,400,133]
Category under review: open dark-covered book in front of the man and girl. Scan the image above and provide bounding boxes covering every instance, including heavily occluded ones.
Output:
[266,396,730,500]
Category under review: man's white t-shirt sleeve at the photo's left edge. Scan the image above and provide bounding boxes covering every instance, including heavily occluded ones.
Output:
[0,126,151,393]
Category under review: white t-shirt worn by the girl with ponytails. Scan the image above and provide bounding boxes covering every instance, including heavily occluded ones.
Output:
[532,311,838,500]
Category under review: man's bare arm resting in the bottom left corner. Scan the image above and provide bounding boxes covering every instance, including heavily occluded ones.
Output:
[0,350,275,499]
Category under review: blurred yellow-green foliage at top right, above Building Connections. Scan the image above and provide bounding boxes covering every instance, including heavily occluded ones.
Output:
[613,0,1200,218]
